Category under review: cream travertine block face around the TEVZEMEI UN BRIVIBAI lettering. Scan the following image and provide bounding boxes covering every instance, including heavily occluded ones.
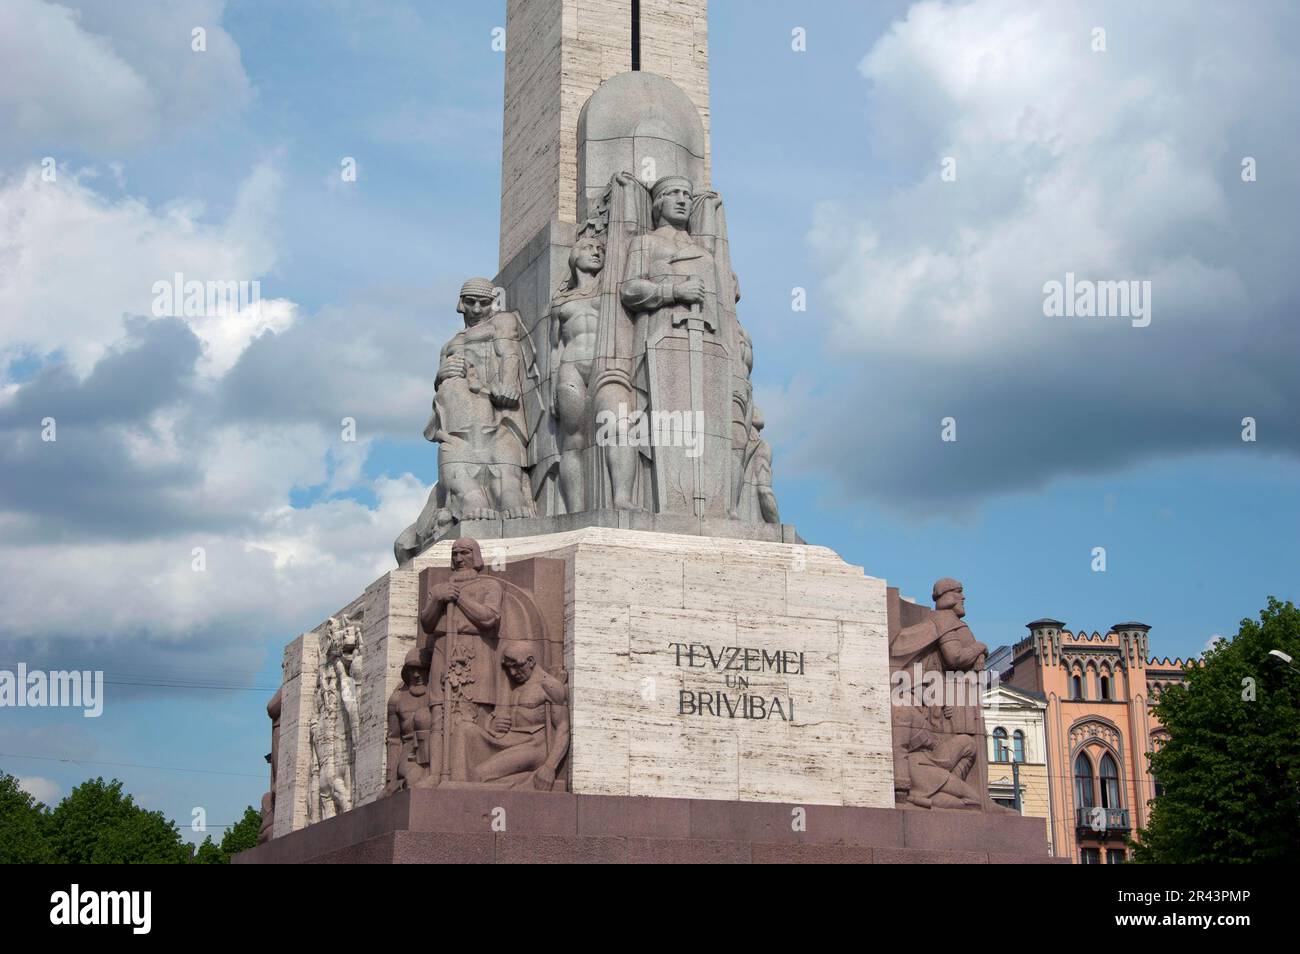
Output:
[412,528,893,807]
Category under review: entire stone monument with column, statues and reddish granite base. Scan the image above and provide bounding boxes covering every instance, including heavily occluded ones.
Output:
[239,0,1047,862]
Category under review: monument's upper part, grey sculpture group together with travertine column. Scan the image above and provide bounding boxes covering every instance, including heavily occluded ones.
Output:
[394,0,801,553]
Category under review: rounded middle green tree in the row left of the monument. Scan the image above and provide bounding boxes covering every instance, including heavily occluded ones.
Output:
[47,779,192,864]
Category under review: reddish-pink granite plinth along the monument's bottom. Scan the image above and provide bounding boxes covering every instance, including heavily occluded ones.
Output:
[234,789,1066,864]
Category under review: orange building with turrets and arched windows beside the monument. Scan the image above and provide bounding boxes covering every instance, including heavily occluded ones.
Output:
[1001,619,1184,864]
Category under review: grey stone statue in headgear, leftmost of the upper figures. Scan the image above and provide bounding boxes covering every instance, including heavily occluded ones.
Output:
[424,278,540,520]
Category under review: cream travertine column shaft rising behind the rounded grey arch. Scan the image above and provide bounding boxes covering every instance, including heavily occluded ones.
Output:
[499,0,709,268]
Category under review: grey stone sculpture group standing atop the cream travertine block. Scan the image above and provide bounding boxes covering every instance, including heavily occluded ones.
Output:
[394,173,780,563]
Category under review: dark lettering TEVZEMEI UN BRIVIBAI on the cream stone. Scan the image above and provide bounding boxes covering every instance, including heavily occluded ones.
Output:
[668,642,803,723]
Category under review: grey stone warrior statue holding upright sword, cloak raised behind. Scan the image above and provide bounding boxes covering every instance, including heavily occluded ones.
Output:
[593,173,737,517]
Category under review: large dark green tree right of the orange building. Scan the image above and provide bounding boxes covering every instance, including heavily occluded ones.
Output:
[1134,597,1300,864]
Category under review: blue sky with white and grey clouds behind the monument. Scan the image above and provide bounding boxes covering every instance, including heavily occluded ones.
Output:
[0,0,1300,824]
